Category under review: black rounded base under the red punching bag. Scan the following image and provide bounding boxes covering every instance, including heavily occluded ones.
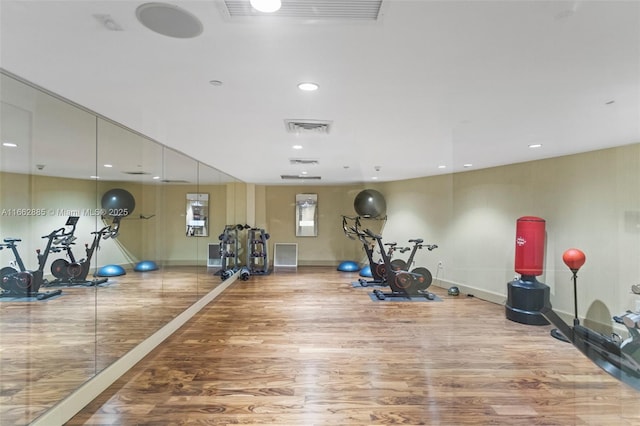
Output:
[505,275,550,325]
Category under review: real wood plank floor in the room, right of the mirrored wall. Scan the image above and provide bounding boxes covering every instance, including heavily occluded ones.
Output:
[68,268,640,426]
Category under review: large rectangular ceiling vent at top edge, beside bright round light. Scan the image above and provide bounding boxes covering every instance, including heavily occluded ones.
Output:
[224,0,382,21]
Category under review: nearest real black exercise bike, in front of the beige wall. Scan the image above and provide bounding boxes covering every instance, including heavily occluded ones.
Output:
[364,229,435,300]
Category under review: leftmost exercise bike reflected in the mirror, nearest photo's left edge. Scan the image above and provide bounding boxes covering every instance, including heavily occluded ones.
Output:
[0,223,74,300]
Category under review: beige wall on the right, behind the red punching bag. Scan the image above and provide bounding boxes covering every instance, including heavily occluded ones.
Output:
[381,144,640,323]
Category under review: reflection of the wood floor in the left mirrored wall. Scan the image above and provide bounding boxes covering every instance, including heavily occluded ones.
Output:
[0,267,220,426]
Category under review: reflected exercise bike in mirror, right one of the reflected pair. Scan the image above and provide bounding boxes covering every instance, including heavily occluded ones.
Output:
[45,216,120,287]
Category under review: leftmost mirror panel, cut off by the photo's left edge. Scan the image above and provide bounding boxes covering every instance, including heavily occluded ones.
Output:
[0,74,96,424]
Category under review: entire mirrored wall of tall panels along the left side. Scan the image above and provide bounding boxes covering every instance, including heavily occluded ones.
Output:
[0,73,236,425]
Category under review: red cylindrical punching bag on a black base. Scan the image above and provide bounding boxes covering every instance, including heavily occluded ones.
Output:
[515,216,545,277]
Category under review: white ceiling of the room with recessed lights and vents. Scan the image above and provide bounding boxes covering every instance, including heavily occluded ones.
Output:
[0,0,640,184]
